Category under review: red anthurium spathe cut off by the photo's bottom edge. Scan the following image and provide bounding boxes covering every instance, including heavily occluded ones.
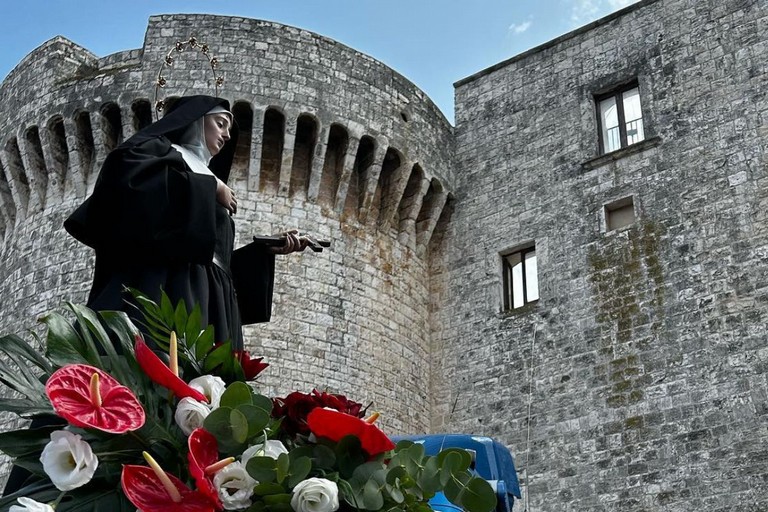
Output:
[121,465,216,512]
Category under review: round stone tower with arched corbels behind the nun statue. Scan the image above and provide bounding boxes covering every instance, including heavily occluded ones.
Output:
[0,15,453,472]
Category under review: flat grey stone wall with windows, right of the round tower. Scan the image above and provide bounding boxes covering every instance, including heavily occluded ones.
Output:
[444,0,768,512]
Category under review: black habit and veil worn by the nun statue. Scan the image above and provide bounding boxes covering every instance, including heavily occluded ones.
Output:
[64,96,275,350]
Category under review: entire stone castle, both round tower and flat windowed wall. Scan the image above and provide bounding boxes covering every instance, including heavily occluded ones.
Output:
[0,0,768,512]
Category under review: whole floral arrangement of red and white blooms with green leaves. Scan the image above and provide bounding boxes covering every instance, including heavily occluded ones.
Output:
[0,290,496,512]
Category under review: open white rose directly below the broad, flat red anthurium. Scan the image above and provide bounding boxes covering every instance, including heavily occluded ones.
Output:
[40,430,99,491]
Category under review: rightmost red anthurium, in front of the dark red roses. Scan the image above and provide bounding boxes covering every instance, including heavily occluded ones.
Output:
[307,407,395,457]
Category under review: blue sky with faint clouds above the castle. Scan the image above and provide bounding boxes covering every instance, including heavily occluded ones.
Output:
[0,0,636,122]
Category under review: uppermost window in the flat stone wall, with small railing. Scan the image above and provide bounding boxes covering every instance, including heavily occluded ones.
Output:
[595,82,645,153]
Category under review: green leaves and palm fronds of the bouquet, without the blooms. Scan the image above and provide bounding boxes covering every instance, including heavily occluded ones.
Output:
[0,290,496,512]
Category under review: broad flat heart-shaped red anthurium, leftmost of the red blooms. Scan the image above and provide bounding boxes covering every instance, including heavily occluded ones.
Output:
[45,364,146,434]
